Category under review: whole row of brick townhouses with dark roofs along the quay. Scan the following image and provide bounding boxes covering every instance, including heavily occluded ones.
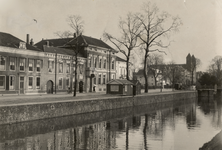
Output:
[0,32,130,94]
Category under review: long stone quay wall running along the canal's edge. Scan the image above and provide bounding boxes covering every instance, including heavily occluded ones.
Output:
[0,91,197,125]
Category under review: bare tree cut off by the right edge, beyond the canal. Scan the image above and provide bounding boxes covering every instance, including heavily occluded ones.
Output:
[209,56,222,85]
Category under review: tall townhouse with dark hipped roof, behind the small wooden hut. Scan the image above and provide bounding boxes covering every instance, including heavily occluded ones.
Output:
[35,34,117,92]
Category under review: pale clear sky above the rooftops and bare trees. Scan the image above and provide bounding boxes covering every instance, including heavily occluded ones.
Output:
[0,0,222,71]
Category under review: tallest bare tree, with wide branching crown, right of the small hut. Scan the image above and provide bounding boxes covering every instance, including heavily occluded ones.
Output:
[136,2,182,93]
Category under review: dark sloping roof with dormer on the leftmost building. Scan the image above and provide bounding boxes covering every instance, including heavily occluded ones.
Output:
[0,32,42,51]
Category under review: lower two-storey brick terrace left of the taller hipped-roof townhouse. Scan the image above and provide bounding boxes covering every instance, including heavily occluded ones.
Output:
[0,32,86,94]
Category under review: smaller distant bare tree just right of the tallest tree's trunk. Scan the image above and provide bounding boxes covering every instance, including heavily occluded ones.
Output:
[147,53,164,88]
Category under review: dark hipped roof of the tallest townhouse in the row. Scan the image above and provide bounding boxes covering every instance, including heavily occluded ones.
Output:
[35,35,115,51]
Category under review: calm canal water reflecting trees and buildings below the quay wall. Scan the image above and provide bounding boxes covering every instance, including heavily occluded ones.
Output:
[0,95,222,150]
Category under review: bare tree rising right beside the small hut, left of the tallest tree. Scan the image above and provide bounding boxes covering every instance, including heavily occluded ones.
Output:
[103,13,140,80]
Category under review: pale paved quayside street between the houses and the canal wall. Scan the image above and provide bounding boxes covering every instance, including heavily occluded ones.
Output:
[0,89,194,106]
